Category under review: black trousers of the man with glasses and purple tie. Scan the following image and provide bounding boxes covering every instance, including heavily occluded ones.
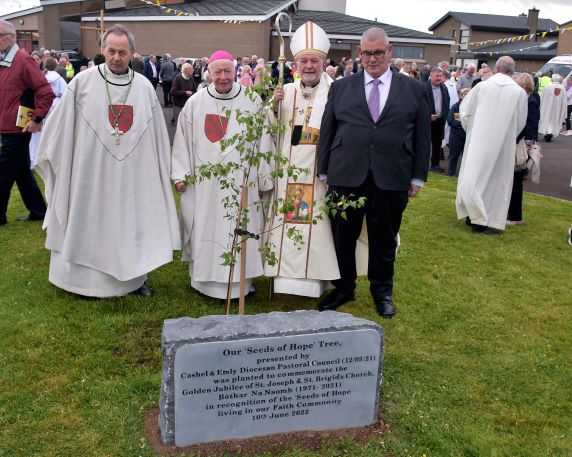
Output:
[328,172,409,296]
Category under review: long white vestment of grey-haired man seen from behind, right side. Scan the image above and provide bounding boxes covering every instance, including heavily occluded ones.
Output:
[456,73,528,230]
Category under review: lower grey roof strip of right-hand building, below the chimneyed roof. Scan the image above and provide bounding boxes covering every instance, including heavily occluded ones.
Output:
[457,40,558,60]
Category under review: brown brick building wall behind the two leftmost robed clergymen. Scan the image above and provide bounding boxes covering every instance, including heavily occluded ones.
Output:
[83,20,270,60]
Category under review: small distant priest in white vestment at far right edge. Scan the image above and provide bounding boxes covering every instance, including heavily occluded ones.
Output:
[538,73,568,143]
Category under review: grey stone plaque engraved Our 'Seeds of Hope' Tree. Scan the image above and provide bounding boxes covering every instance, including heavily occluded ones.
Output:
[159,311,383,446]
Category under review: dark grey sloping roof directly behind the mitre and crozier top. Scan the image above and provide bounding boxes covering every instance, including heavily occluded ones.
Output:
[280,10,448,41]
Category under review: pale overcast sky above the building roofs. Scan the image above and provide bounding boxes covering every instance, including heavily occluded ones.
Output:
[0,0,572,32]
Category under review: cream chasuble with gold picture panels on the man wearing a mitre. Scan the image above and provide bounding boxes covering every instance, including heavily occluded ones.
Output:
[265,74,340,297]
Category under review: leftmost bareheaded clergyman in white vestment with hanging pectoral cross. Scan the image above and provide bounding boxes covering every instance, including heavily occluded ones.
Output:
[36,26,180,297]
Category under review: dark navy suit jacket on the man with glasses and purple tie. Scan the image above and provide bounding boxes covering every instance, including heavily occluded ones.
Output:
[318,70,431,191]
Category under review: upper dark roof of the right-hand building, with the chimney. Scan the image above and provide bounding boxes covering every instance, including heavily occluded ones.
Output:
[429,11,558,33]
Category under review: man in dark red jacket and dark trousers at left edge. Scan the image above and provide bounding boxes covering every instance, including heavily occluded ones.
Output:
[0,20,55,226]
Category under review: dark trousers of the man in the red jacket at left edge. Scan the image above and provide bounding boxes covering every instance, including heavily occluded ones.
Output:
[0,133,46,221]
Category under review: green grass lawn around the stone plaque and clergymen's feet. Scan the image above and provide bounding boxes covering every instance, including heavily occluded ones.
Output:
[0,175,572,457]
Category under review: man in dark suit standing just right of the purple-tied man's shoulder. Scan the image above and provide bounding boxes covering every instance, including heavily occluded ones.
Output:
[424,67,451,171]
